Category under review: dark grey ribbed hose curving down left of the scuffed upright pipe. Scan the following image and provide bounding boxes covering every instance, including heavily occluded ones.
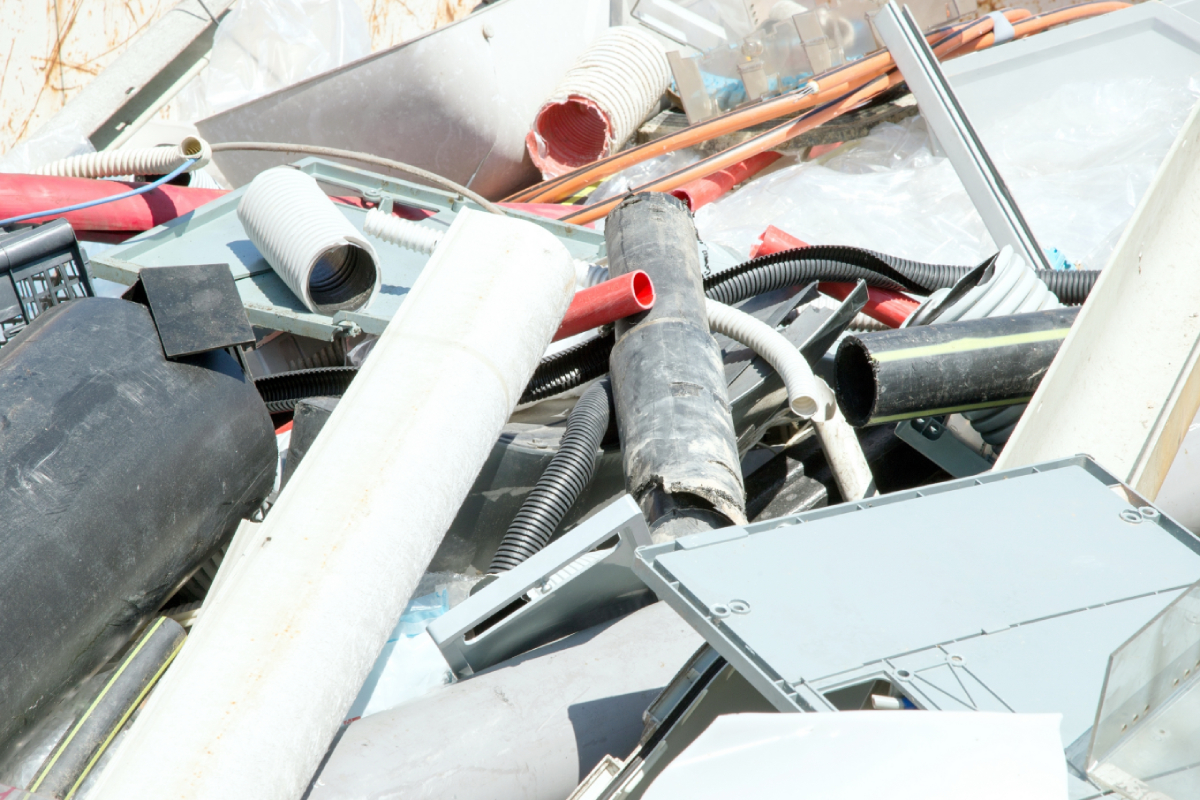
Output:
[487,379,612,573]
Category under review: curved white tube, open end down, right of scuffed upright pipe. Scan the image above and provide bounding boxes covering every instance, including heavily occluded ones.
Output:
[704,300,836,420]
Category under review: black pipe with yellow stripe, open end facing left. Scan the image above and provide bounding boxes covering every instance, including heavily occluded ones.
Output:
[836,308,1079,427]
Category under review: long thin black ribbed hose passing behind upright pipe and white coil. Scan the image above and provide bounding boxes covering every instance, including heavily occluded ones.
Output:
[521,245,1100,403]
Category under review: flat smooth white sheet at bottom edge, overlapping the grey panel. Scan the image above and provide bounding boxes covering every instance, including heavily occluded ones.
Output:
[644,711,1067,800]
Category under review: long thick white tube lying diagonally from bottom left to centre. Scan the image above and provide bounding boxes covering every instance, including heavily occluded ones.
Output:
[92,210,575,800]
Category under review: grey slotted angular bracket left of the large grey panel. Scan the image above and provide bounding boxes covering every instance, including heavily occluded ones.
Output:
[428,494,655,678]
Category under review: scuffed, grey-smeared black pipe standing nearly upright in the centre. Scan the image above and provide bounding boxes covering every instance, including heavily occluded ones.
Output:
[605,192,745,541]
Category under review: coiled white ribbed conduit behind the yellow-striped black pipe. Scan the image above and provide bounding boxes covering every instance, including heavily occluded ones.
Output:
[905,245,1062,449]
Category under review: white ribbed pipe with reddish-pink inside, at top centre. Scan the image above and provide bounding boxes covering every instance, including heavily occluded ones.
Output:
[526,25,671,178]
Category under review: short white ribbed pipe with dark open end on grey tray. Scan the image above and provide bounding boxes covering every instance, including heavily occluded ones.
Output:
[238,167,383,314]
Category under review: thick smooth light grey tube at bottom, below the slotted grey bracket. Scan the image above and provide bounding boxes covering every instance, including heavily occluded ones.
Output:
[307,603,702,800]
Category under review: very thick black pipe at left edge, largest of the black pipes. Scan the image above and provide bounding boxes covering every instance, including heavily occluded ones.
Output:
[0,297,278,742]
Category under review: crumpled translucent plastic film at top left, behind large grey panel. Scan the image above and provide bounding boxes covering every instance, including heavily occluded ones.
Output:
[179,0,371,122]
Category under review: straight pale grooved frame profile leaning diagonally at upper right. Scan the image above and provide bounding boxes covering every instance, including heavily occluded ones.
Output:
[875,2,1050,270]
